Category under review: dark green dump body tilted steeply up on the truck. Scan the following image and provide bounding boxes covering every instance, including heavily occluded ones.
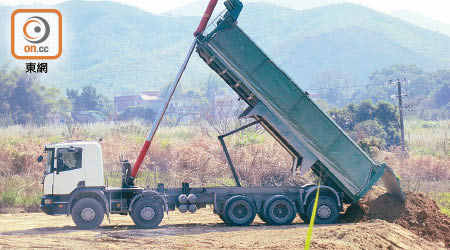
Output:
[197,13,386,202]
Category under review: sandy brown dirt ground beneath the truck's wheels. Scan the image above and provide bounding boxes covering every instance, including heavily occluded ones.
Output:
[0,208,445,250]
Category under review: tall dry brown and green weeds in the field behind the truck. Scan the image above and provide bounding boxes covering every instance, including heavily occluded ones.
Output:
[0,121,450,212]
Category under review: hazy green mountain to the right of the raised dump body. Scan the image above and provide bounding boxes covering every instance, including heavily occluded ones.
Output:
[240,4,450,83]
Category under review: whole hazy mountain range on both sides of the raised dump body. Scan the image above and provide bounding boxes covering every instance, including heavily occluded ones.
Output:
[0,1,450,96]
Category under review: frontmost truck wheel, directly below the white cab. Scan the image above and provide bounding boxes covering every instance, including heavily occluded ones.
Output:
[72,198,105,229]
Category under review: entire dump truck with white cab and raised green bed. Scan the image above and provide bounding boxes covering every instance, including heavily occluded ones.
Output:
[38,0,404,229]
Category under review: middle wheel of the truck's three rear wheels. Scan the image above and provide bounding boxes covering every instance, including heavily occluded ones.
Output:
[263,195,297,226]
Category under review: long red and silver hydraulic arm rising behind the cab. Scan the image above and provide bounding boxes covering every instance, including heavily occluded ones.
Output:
[130,0,217,179]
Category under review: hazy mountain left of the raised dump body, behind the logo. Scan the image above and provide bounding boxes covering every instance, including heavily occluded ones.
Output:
[0,1,209,96]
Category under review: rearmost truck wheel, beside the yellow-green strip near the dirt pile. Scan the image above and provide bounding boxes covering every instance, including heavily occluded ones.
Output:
[307,196,339,224]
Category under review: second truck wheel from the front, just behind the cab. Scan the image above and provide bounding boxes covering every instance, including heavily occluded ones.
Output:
[131,198,164,228]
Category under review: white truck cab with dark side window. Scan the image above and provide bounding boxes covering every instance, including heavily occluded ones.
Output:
[43,141,104,195]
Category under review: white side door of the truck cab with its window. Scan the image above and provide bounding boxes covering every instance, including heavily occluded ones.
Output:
[53,147,84,195]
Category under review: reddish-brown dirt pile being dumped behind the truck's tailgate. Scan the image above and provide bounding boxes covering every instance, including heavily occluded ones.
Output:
[341,187,450,248]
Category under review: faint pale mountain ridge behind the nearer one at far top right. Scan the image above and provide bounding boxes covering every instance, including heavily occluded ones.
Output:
[391,10,450,36]
